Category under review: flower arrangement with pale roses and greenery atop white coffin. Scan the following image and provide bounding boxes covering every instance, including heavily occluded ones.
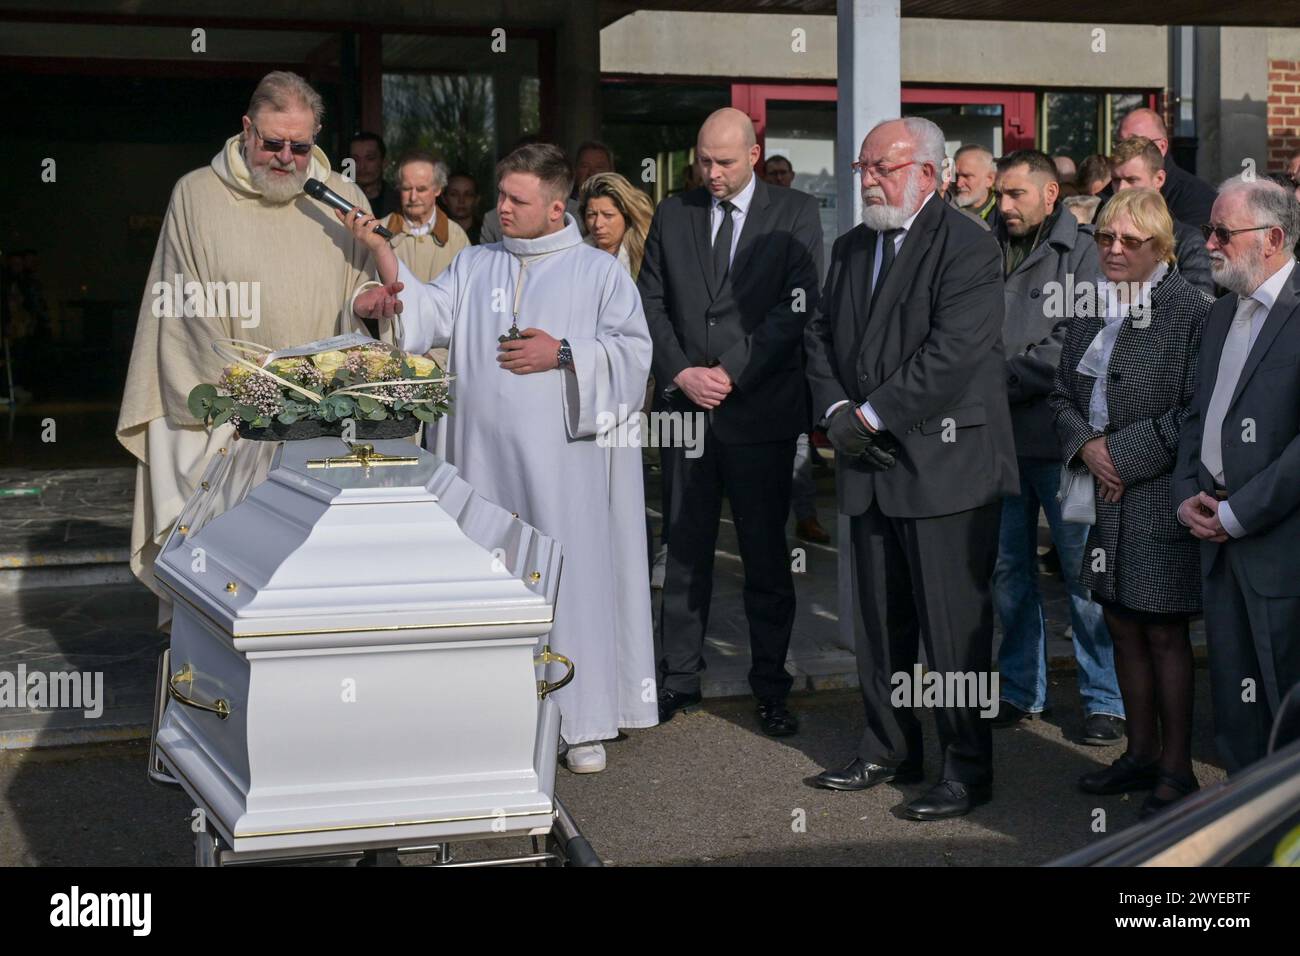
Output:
[189,336,451,441]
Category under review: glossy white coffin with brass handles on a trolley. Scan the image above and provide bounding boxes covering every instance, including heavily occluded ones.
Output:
[155,438,560,856]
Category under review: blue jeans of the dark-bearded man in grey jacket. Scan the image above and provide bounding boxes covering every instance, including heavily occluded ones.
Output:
[993,458,1125,717]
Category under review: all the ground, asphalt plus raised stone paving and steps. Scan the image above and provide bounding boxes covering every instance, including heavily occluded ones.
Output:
[0,455,1221,865]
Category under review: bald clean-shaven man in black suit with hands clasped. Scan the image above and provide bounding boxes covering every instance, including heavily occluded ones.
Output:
[637,109,822,736]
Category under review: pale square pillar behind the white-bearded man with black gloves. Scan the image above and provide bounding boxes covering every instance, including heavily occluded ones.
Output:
[837,0,902,650]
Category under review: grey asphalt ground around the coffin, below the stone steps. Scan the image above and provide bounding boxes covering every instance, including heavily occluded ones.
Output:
[0,670,1222,866]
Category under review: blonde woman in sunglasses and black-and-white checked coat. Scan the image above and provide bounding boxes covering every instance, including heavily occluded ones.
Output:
[1048,189,1212,817]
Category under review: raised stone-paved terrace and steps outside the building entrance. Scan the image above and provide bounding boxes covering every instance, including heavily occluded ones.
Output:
[0,468,1199,749]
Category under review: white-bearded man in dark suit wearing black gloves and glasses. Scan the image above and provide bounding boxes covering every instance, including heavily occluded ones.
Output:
[805,117,1019,819]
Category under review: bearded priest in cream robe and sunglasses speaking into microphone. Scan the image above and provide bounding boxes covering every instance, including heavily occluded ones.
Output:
[117,72,382,626]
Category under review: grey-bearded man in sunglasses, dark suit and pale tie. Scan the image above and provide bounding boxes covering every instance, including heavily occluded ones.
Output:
[1170,178,1300,771]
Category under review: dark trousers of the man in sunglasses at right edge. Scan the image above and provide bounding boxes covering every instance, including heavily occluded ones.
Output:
[1204,541,1300,773]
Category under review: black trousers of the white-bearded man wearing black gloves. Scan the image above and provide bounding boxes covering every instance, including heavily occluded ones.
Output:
[850,501,1002,786]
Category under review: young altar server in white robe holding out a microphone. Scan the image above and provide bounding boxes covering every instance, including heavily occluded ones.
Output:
[345,144,658,773]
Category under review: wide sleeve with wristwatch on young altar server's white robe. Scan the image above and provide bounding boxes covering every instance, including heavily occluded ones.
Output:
[563,256,651,438]
